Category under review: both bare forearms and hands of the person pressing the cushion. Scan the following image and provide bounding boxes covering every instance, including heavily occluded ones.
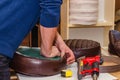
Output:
[40,25,75,64]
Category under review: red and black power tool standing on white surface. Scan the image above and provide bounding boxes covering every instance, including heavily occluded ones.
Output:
[78,56,102,80]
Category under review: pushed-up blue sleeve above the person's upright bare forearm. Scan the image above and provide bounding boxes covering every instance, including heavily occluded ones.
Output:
[40,0,62,28]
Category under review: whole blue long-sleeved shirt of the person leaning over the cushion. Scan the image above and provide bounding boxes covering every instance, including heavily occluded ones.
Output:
[0,0,62,58]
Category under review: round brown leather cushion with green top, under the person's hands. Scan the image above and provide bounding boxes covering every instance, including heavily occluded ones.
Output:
[11,47,66,76]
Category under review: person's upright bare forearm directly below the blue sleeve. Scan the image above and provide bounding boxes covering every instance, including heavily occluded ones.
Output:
[40,25,57,57]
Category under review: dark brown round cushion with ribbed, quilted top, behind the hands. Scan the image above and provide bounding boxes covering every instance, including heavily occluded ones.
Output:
[64,39,101,60]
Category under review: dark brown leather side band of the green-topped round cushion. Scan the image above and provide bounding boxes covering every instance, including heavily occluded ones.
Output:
[11,53,66,76]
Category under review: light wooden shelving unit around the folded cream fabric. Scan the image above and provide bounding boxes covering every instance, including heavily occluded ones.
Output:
[60,0,115,47]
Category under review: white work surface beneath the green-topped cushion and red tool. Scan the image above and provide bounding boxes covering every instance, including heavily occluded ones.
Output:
[18,62,117,80]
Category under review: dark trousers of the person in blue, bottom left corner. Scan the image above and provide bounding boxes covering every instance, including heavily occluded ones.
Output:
[0,55,10,80]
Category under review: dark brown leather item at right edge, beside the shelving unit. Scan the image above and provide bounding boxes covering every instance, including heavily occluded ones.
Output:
[108,30,120,57]
